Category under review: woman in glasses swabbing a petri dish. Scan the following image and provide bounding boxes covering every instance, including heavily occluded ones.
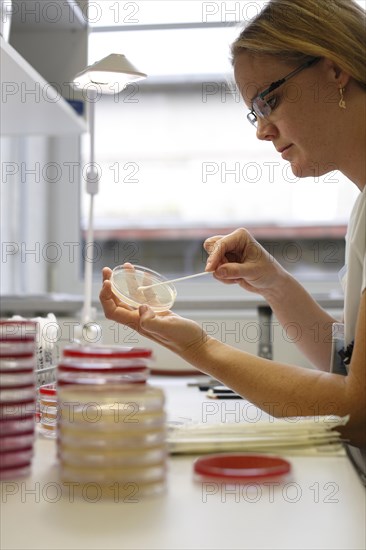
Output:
[100,0,366,462]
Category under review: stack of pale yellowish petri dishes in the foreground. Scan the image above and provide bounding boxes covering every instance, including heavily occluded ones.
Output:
[58,384,167,502]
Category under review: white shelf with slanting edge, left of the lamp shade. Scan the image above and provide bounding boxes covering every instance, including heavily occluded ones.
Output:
[0,37,86,136]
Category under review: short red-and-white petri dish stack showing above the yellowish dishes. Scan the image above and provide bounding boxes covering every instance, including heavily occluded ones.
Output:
[57,345,152,387]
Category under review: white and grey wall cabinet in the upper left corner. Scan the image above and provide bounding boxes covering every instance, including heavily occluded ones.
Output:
[0,0,88,136]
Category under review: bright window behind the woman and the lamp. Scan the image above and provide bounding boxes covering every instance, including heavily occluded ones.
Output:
[78,1,357,288]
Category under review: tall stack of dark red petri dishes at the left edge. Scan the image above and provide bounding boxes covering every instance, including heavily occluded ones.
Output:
[0,320,37,479]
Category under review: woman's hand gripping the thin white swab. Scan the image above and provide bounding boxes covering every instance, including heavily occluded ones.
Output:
[203,229,285,295]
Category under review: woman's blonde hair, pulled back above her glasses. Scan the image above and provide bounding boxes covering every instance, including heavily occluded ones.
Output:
[231,0,366,89]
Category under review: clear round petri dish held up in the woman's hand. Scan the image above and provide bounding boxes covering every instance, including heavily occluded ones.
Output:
[111,264,177,312]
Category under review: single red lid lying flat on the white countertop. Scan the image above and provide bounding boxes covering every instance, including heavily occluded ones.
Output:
[194,453,291,480]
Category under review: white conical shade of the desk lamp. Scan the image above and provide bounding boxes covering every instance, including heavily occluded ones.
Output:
[73,53,147,94]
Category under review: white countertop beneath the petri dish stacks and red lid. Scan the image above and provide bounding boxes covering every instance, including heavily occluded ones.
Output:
[0,377,366,550]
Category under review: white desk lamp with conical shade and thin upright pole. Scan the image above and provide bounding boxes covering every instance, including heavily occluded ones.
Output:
[73,53,147,338]
